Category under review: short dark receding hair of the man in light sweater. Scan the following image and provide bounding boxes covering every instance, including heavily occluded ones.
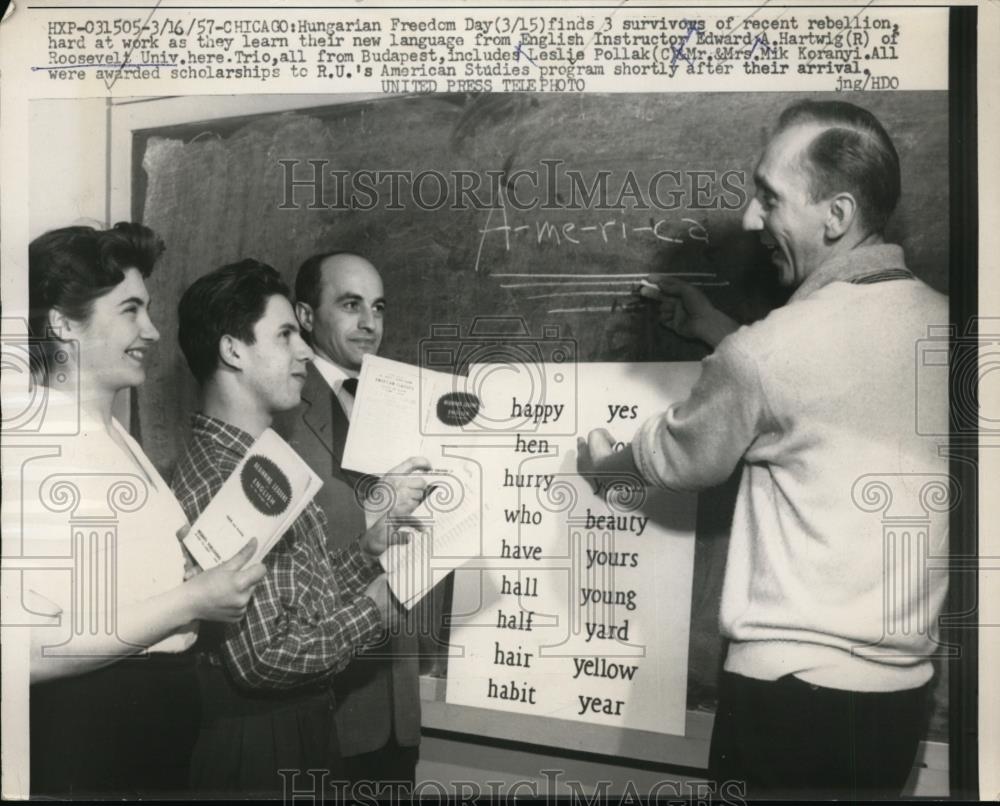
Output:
[778,100,900,233]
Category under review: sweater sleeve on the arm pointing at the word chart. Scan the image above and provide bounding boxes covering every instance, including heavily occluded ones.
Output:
[632,329,767,491]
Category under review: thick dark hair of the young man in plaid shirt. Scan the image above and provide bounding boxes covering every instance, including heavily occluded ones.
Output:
[177,258,289,384]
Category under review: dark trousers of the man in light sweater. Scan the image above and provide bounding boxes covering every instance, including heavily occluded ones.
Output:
[709,672,930,800]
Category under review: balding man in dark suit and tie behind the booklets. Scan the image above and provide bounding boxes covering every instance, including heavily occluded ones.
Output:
[281,252,428,786]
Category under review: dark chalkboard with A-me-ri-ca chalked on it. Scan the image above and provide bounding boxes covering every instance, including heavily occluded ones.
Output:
[134,92,949,738]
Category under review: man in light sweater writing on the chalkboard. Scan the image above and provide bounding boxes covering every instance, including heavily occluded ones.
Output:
[579,101,948,798]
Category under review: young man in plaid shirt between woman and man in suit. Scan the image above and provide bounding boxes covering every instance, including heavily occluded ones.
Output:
[173,260,428,795]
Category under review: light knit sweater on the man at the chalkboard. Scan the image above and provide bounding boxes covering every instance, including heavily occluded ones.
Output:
[633,244,950,691]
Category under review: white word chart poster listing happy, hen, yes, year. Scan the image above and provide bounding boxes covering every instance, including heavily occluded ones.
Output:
[446,363,700,735]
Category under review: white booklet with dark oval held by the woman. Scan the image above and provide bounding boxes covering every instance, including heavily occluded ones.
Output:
[184,428,323,570]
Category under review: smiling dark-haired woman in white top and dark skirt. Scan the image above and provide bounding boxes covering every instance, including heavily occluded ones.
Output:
[20,223,264,797]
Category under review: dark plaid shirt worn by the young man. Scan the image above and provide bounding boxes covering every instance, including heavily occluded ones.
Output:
[173,414,383,689]
